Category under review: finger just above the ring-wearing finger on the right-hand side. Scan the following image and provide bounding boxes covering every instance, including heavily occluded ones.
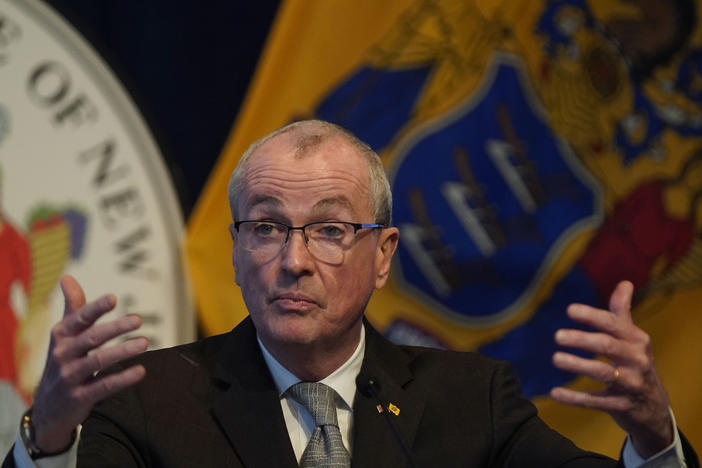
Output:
[555,329,645,366]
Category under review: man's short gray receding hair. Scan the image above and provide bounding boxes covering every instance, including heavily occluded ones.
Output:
[227,120,392,226]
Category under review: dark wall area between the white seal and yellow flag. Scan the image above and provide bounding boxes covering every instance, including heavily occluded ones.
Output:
[45,0,279,216]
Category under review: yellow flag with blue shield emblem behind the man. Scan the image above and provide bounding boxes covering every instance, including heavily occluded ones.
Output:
[187,0,702,457]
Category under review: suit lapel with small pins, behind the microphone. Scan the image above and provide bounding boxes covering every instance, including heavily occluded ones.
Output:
[352,322,424,467]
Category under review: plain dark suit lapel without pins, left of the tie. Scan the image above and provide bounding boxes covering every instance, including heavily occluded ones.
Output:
[211,318,297,468]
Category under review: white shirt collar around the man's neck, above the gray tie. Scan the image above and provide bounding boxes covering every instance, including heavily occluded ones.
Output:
[256,324,366,408]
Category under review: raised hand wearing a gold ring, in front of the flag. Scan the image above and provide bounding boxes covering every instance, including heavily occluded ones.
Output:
[551,281,674,458]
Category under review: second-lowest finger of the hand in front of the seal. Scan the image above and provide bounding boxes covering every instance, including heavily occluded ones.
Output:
[63,337,149,385]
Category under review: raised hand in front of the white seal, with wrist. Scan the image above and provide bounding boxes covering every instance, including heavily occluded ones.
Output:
[32,276,148,453]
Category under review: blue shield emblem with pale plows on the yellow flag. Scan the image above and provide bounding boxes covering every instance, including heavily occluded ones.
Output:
[390,55,601,324]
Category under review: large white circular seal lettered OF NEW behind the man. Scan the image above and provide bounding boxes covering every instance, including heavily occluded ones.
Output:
[0,0,195,453]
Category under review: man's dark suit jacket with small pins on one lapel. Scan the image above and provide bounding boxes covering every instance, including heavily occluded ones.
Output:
[2,319,696,468]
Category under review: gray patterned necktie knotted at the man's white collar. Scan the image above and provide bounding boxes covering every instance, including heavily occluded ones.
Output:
[288,382,351,468]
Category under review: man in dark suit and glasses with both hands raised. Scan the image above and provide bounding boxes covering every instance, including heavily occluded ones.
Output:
[6,121,697,467]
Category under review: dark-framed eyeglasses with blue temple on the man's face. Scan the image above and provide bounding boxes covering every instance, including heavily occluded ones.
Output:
[234,221,385,263]
